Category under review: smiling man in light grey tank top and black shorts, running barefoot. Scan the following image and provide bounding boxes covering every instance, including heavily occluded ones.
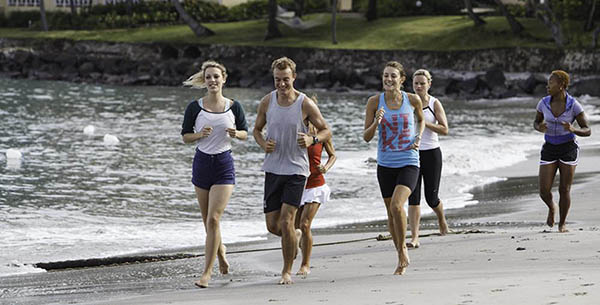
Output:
[253,57,331,285]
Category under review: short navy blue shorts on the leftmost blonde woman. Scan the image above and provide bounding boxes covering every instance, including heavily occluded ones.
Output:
[192,149,235,190]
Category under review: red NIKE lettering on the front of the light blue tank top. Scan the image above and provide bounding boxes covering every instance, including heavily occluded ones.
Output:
[381,113,412,151]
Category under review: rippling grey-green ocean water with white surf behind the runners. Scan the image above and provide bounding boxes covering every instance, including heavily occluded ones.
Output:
[0,78,600,276]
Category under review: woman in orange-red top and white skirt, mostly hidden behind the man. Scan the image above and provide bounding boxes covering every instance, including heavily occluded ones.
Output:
[296,96,337,276]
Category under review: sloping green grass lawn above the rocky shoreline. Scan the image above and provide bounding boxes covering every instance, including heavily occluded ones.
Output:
[0,14,591,51]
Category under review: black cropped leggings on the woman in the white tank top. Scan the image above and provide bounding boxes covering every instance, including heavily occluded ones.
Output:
[408,147,442,208]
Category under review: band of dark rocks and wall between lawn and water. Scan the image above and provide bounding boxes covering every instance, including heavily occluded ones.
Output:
[0,38,600,98]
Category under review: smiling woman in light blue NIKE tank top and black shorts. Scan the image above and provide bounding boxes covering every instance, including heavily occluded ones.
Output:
[363,61,425,275]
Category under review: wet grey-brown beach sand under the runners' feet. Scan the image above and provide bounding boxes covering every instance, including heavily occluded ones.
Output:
[0,147,600,305]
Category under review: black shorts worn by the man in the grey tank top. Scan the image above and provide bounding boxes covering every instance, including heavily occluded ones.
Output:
[263,173,306,214]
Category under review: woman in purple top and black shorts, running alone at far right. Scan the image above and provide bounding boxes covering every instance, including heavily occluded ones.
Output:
[533,70,592,232]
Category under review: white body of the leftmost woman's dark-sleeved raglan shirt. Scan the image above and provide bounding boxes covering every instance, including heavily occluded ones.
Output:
[195,99,235,155]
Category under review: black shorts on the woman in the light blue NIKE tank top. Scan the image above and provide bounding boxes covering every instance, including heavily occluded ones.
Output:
[377,165,419,198]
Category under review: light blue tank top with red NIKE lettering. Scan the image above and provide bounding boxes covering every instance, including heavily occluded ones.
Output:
[377,91,419,168]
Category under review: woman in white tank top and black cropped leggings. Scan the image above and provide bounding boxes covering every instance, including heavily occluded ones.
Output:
[406,69,448,248]
